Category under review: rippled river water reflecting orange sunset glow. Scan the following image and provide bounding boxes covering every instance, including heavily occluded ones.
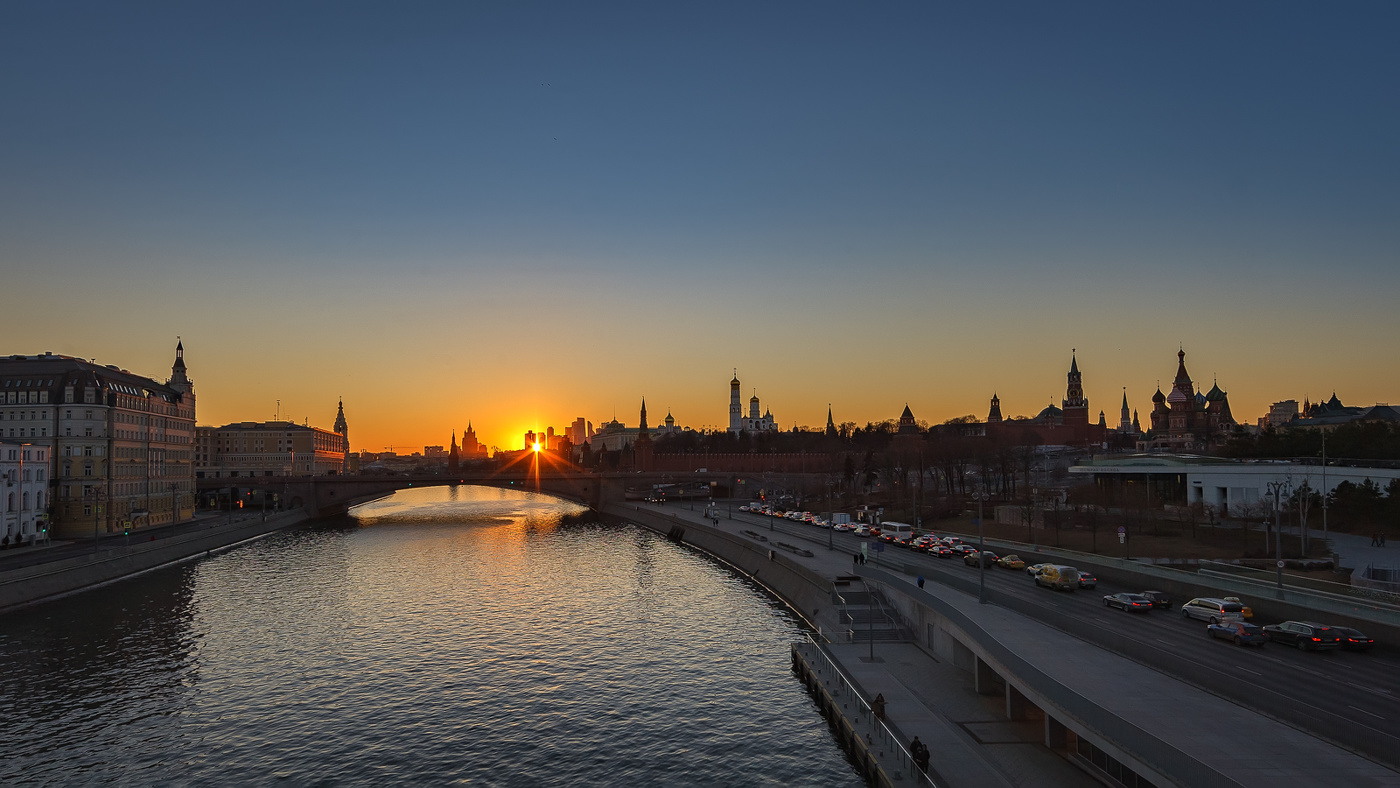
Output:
[0,487,864,787]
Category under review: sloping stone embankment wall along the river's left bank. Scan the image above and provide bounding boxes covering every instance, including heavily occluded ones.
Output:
[0,511,308,612]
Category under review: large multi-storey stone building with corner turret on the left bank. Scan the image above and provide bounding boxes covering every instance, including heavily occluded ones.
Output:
[0,343,196,539]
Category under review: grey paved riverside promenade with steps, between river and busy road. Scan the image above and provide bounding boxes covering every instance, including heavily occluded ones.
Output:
[605,504,1400,787]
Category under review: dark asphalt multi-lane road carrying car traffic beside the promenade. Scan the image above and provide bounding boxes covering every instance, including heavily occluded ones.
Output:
[734,512,1400,766]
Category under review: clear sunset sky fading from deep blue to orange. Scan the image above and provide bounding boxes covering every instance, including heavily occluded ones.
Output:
[0,0,1400,451]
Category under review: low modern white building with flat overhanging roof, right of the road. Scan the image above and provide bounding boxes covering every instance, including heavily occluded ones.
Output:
[1070,455,1400,516]
